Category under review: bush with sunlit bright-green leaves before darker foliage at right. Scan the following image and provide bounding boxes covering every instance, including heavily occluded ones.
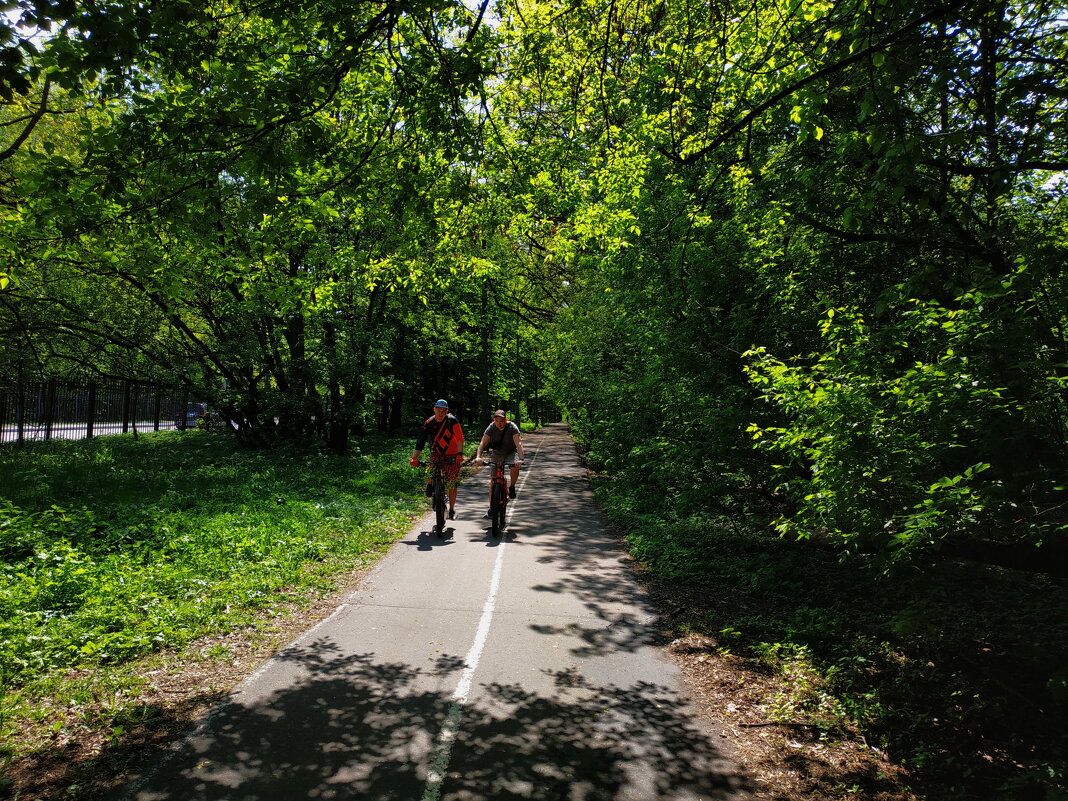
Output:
[747,284,1063,560]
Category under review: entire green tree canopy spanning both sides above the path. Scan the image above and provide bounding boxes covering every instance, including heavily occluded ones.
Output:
[0,0,1068,564]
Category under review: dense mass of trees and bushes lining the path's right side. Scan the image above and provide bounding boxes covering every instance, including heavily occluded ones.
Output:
[494,1,1068,554]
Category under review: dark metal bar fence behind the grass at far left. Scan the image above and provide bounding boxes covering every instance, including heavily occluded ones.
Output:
[0,380,195,444]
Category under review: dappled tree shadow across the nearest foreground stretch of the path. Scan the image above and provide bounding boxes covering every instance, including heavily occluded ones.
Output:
[114,641,744,801]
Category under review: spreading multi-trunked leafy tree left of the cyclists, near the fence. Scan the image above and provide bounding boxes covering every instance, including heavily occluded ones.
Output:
[3,3,504,447]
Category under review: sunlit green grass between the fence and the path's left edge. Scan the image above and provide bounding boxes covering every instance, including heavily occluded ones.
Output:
[0,431,422,754]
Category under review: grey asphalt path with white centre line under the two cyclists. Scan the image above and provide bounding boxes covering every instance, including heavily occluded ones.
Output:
[120,425,748,801]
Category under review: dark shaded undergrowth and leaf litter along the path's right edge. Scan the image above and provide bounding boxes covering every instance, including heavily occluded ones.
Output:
[587,435,1068,801]
